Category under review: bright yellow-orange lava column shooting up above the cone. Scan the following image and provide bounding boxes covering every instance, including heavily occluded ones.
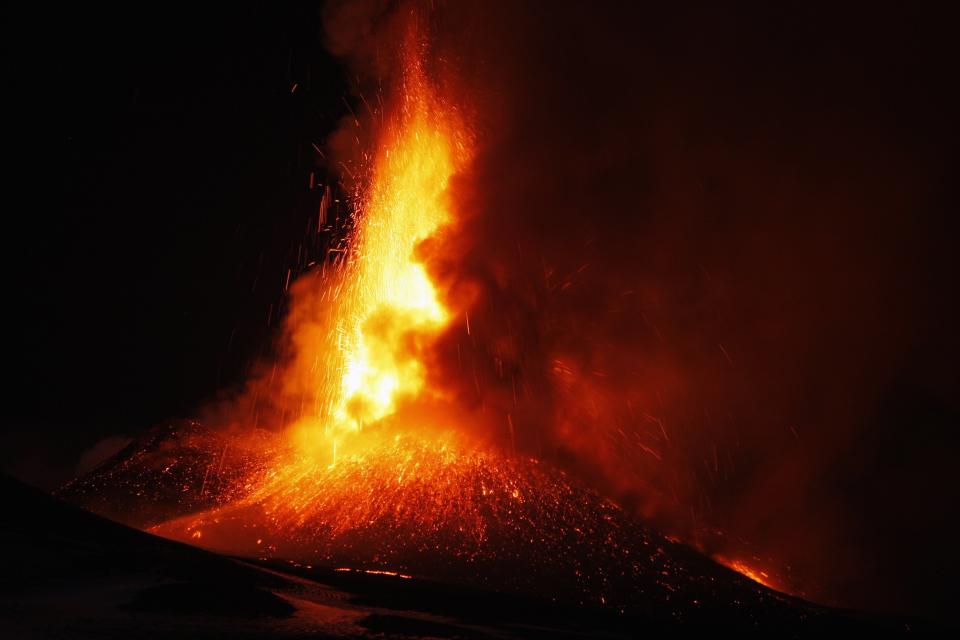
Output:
[286,38,469,463]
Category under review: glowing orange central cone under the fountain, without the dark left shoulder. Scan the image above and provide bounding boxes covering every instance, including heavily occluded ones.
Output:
[149,435,800,611]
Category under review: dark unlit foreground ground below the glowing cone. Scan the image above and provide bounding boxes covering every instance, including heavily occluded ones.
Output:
[11,470,925,638]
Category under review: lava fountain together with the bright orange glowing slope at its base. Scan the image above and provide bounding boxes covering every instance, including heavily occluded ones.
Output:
[154,22,535,561]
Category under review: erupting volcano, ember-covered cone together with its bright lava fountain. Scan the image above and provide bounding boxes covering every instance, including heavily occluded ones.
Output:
[62,13,800,611]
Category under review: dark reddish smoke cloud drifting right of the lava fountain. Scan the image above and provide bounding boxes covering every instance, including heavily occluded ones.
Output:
[327,0,960,614]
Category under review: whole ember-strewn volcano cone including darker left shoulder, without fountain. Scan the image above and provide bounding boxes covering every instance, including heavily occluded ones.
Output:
[52,422,916,628]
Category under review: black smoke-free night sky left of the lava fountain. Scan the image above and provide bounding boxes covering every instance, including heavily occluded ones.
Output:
[0,3,346,486]
